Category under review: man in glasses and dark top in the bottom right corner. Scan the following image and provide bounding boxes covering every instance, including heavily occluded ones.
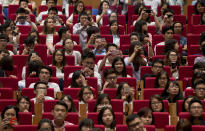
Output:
[189,99,205,125]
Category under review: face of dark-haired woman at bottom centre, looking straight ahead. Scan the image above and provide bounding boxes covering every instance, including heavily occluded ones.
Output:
[102,109,113,127]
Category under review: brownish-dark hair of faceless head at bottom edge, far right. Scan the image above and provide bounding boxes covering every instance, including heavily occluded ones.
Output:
[176,118,192,131]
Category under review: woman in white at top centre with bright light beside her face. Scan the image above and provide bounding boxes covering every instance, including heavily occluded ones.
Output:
[96,1,110,25]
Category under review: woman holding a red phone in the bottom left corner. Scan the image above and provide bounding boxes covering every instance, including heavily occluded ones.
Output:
[0,105,19,131]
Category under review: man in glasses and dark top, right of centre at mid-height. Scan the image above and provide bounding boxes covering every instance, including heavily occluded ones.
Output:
[142,59,164,81]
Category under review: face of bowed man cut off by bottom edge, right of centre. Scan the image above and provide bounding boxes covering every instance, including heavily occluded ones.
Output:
[128,118,144,131]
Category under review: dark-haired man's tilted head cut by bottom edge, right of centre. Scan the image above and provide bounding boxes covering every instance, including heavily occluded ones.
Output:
[126,114,146,131]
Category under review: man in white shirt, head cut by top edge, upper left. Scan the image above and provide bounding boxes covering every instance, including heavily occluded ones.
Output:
[36,0,62,23]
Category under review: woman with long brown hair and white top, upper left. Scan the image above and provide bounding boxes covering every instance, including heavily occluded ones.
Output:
[40,18,58,54]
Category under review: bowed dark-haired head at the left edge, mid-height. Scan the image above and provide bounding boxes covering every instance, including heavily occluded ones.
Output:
[0,55,14,71]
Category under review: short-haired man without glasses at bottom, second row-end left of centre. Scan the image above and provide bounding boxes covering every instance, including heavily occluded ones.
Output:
[52,101,73,131]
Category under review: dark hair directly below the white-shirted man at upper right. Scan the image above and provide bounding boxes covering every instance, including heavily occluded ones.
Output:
[163,39,178,54]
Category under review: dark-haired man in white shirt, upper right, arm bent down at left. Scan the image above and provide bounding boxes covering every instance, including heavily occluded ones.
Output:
[154,26,174,55]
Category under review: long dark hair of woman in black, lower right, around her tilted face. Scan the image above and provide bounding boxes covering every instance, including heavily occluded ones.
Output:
[161,81,183,103]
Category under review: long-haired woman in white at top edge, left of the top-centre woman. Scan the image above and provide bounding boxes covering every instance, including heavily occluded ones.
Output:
[66,1,85,26]
